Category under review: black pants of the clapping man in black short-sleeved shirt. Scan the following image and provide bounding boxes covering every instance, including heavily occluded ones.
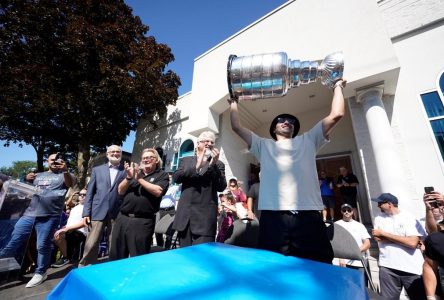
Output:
[109,214,156,260]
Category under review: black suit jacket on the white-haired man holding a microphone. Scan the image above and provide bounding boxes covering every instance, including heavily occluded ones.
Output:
[173,156,227,236]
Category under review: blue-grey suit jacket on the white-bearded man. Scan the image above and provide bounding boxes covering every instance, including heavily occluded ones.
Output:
[82,163,126,221]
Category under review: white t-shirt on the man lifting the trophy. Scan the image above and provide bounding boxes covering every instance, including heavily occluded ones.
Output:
[250,121,328,210]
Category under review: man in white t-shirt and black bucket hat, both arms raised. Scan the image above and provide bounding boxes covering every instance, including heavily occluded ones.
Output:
[228,79,345,264]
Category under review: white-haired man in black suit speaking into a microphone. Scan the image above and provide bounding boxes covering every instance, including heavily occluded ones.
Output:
[173,131,227,247]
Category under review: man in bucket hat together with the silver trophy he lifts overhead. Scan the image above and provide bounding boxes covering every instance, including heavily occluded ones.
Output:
[228,53,346,263]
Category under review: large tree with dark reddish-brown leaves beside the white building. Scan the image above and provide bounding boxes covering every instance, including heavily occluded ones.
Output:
[0,0,180,185]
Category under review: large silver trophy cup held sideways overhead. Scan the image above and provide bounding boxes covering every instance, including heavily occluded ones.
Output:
[227,52,344,100]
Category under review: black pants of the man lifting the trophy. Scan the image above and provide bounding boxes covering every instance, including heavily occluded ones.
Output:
[259,210,333,264]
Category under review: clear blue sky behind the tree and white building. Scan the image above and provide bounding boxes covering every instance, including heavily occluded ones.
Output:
[0,0,287,167]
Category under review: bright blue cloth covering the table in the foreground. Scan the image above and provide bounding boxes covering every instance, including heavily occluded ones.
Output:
[48,243,368,300]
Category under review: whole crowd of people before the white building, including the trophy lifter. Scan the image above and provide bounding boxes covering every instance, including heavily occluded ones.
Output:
[0,80,444,299]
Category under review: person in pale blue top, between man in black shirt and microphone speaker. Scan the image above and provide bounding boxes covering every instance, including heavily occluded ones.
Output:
[155,173,180,249]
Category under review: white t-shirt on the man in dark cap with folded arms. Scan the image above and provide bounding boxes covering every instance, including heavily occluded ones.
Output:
[374,211,424,275]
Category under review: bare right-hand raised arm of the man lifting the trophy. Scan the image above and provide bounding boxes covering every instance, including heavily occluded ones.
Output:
[322,79,346,138]
